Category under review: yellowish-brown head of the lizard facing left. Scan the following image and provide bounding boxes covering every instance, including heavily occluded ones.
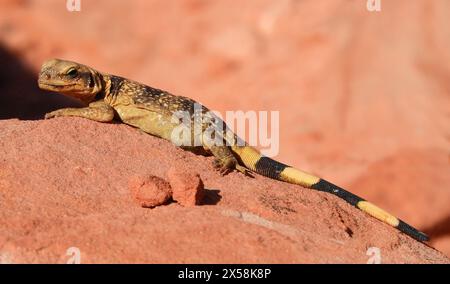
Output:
[38,59,103,103]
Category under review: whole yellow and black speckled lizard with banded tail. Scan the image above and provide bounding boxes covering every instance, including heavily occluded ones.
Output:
[38,59,428,241]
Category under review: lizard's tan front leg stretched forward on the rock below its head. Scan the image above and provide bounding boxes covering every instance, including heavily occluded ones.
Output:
[45,101,114,122]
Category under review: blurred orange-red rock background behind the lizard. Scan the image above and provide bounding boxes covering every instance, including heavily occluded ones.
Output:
[0,0,450,255]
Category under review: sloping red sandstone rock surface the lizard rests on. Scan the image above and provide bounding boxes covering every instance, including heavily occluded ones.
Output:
[0,118,450,263]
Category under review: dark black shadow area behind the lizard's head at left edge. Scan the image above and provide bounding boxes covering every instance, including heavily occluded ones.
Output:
[0,43,81,120]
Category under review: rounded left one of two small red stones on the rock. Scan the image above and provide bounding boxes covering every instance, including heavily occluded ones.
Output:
[129,176,172,208]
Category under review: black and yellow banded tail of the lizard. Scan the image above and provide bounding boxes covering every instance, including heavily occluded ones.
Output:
[232,146,428,242]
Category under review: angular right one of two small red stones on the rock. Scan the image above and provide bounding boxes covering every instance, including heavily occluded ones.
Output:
[167,167,205,207]
